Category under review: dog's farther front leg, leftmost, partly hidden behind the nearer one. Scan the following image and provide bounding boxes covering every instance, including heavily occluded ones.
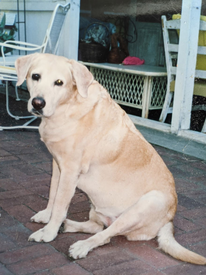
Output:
[31,159,60,223]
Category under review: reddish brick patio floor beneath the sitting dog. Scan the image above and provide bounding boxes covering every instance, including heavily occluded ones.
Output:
[0,89,206,275]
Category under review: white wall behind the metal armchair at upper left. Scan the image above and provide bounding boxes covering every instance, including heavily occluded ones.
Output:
[1,0,80,59]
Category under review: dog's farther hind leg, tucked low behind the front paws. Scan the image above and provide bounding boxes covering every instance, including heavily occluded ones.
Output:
[63,207,104,234]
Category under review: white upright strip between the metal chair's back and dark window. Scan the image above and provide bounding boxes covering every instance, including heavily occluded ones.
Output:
[62,0,80,60]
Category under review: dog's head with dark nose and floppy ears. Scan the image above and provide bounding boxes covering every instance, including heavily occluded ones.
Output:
[15,53,93,117]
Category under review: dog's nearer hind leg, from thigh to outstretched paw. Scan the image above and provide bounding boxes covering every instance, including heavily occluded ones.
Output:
[69,191,169,259]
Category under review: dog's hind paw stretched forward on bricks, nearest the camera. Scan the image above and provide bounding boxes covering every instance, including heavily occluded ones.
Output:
[69,240,90,259]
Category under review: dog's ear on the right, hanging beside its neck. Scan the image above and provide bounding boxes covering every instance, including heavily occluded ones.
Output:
[69,60,94,97]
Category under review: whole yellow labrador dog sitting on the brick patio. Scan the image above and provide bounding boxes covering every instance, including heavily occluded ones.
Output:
[16,54,206,264]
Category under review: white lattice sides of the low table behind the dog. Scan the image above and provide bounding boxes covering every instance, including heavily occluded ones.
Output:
[90,67,167,109]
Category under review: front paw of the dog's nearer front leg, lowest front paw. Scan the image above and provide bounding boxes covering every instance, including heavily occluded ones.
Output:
[28,226,57,243]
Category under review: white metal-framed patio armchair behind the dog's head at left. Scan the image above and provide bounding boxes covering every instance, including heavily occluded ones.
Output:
[0,3,70,130]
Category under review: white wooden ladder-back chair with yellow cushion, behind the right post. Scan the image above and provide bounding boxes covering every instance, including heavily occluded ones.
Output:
[159,15,206,133]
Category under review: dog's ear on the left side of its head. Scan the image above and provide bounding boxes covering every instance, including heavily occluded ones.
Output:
[15,53,38,86]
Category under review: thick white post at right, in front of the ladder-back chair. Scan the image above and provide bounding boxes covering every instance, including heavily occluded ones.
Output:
[171,0,202,133]
